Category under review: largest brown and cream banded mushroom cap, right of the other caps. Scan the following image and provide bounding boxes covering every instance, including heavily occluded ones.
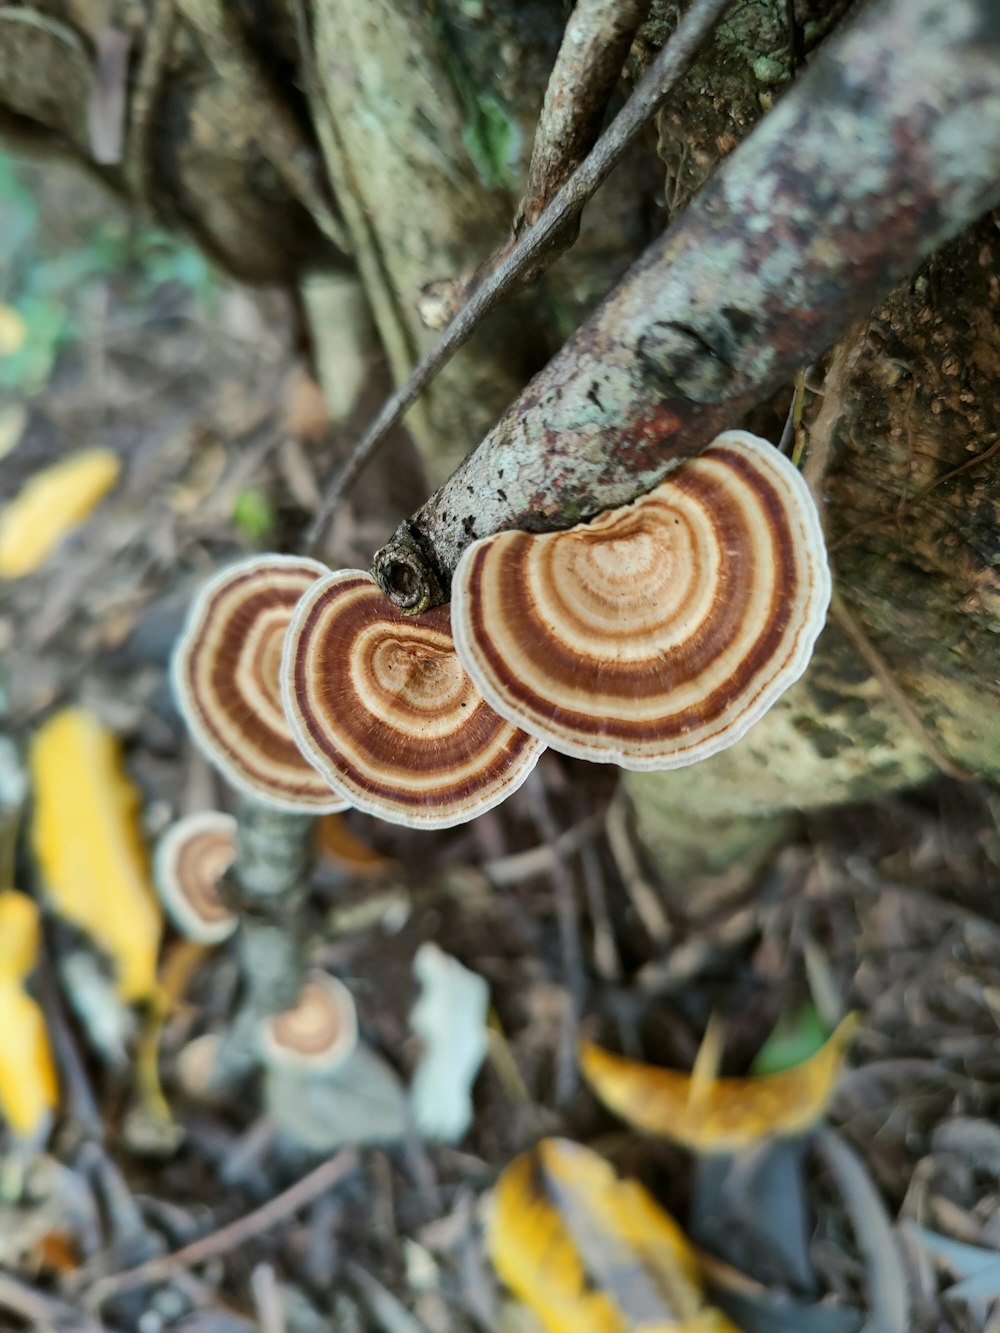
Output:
[452,431,831,769]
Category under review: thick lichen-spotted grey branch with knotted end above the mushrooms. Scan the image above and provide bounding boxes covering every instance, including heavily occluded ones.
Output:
[373,0,1000,612]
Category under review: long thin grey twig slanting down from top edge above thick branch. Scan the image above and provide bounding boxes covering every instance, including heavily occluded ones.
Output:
[305,0,729,551]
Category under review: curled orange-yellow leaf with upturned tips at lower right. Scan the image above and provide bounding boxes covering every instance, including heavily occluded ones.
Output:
[580,1014,857,1153]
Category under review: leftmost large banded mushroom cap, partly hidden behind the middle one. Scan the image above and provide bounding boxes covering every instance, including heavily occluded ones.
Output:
[173,555,347,814]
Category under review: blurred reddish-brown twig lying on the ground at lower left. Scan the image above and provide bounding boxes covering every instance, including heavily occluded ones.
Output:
[87,1152,357,1306]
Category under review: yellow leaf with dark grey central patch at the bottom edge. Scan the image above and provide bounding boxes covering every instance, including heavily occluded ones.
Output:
[488,1138,735,1333]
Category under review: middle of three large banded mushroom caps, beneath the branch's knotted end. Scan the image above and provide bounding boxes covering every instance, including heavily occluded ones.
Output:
[281,569,544,828]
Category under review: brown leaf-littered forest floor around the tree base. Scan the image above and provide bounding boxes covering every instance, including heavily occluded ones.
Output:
[0,148,1000,1333]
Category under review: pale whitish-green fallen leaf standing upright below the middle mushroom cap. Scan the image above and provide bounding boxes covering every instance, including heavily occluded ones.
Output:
[409,944,489,1142]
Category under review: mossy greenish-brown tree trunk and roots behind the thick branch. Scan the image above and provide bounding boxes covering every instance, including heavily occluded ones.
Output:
[0,0,1000,885]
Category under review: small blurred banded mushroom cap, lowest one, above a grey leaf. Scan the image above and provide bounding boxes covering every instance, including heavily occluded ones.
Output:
[260,972,357,1073]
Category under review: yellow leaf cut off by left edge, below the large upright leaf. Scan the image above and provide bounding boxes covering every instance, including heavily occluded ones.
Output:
[0,889,59,1137]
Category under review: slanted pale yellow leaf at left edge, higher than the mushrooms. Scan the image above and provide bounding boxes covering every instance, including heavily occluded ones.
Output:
[0,449,120,579]
